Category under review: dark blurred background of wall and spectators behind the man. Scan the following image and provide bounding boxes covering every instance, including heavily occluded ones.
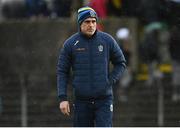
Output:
[0,0,180,127]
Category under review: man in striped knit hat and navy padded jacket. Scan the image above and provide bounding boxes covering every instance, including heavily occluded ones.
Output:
[57,7,126,127]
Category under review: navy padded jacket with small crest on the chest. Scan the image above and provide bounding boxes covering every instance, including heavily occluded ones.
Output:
[57,31,126,101]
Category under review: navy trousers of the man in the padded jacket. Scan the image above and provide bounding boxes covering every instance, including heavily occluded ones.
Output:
[74,98,113,127]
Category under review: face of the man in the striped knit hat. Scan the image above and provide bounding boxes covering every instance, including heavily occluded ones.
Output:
[80,18,96,37]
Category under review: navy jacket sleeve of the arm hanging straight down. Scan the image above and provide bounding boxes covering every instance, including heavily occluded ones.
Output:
[57,42,71,102]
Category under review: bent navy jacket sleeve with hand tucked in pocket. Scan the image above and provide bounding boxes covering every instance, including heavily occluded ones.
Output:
[109,38,126,85]
